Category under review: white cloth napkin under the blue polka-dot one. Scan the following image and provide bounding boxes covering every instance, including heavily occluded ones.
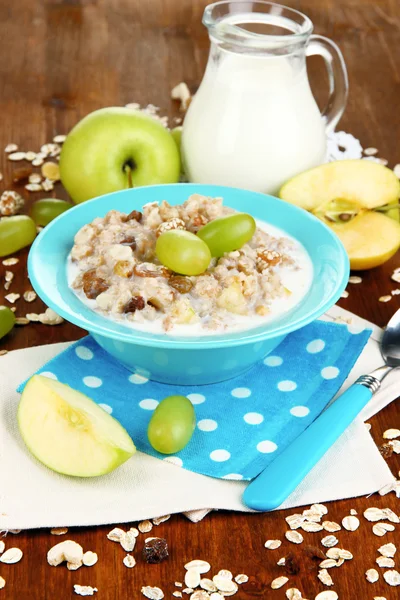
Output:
[0,307,394,530]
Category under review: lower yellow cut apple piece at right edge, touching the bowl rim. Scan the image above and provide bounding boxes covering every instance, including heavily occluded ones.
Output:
[330,211,400,270]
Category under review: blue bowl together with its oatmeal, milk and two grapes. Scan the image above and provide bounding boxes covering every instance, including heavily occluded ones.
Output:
[29,184,348,385]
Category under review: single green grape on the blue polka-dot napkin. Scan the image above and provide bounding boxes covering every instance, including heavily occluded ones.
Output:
[147,396,196,454]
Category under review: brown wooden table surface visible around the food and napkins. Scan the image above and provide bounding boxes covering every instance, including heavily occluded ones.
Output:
[0,0,400,600]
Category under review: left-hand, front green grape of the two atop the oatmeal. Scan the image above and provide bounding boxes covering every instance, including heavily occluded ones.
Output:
[156,229,211,275]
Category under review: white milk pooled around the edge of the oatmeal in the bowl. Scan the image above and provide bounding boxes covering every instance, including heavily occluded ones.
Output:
[67,219,313,337]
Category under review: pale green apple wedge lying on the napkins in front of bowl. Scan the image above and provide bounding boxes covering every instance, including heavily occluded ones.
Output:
[18,375,136,477]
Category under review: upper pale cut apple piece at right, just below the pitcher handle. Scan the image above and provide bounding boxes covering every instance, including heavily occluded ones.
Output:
[279,160,400,220]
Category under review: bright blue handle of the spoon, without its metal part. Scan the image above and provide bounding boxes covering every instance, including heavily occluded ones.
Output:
[243,383,372,510]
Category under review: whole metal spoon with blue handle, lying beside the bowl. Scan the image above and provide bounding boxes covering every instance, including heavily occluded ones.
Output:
[243,309,400,510]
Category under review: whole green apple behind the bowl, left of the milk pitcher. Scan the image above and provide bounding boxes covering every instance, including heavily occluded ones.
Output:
[60,107,180,203]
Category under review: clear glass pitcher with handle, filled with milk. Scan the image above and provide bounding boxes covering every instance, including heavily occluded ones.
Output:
[182,0,348,194]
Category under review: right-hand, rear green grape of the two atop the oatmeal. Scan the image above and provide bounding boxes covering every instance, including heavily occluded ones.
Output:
[197,213,256,256]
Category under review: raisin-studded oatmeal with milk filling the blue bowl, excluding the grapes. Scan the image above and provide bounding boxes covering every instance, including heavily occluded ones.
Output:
[68,194,313,335]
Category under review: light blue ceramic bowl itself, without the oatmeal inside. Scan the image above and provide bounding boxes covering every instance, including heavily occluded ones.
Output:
[28,184,349,385]
